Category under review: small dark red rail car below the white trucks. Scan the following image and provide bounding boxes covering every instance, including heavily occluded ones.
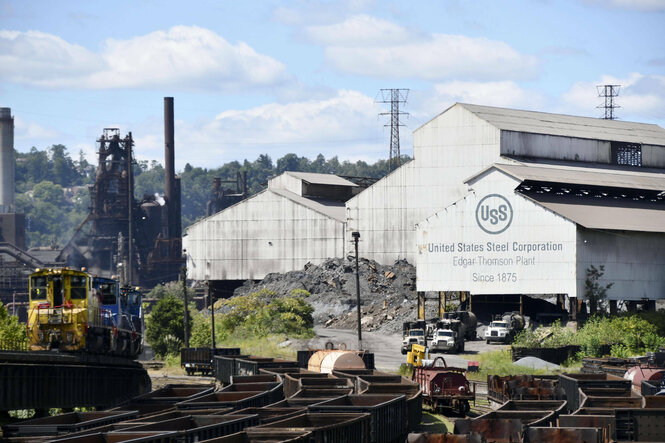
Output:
[413,357,475,415]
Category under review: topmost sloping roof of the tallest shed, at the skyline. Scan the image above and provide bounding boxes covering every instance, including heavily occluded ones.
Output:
[456,103,665,146]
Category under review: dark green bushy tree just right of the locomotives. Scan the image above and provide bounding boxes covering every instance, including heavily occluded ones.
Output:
[146,295,185,357]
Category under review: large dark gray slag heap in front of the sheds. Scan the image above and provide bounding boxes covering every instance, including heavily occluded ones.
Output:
[234,257,417,333]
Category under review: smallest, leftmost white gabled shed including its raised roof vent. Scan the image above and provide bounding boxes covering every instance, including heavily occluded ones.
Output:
[183,172,358,280]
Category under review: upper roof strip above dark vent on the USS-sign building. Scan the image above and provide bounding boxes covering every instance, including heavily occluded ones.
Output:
[478,163,665,191]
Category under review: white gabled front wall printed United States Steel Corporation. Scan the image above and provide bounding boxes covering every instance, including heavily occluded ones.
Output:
[416,170,576,296]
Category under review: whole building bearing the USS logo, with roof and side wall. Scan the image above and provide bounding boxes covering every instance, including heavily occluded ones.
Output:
[416,164,665,301]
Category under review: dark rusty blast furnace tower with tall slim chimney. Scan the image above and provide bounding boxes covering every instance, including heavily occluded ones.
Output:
[58,97,183,287]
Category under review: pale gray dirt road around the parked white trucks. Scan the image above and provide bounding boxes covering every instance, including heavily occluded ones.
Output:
[308,327,508,372]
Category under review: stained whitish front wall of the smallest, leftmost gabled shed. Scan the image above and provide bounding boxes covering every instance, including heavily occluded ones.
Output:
[183,190,345,280]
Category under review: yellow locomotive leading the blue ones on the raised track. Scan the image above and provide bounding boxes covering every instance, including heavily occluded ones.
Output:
[28,268,104,351]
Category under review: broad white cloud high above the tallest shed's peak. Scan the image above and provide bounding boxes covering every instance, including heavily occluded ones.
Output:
[306,15,539,81]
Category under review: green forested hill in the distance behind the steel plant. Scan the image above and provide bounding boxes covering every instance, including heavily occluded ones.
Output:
[16,145,409,247]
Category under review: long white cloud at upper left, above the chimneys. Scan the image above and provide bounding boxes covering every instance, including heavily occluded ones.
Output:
[0,26,289,90]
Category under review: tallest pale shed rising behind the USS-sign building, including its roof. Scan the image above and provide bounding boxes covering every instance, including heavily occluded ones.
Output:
[346,103,665,264]
